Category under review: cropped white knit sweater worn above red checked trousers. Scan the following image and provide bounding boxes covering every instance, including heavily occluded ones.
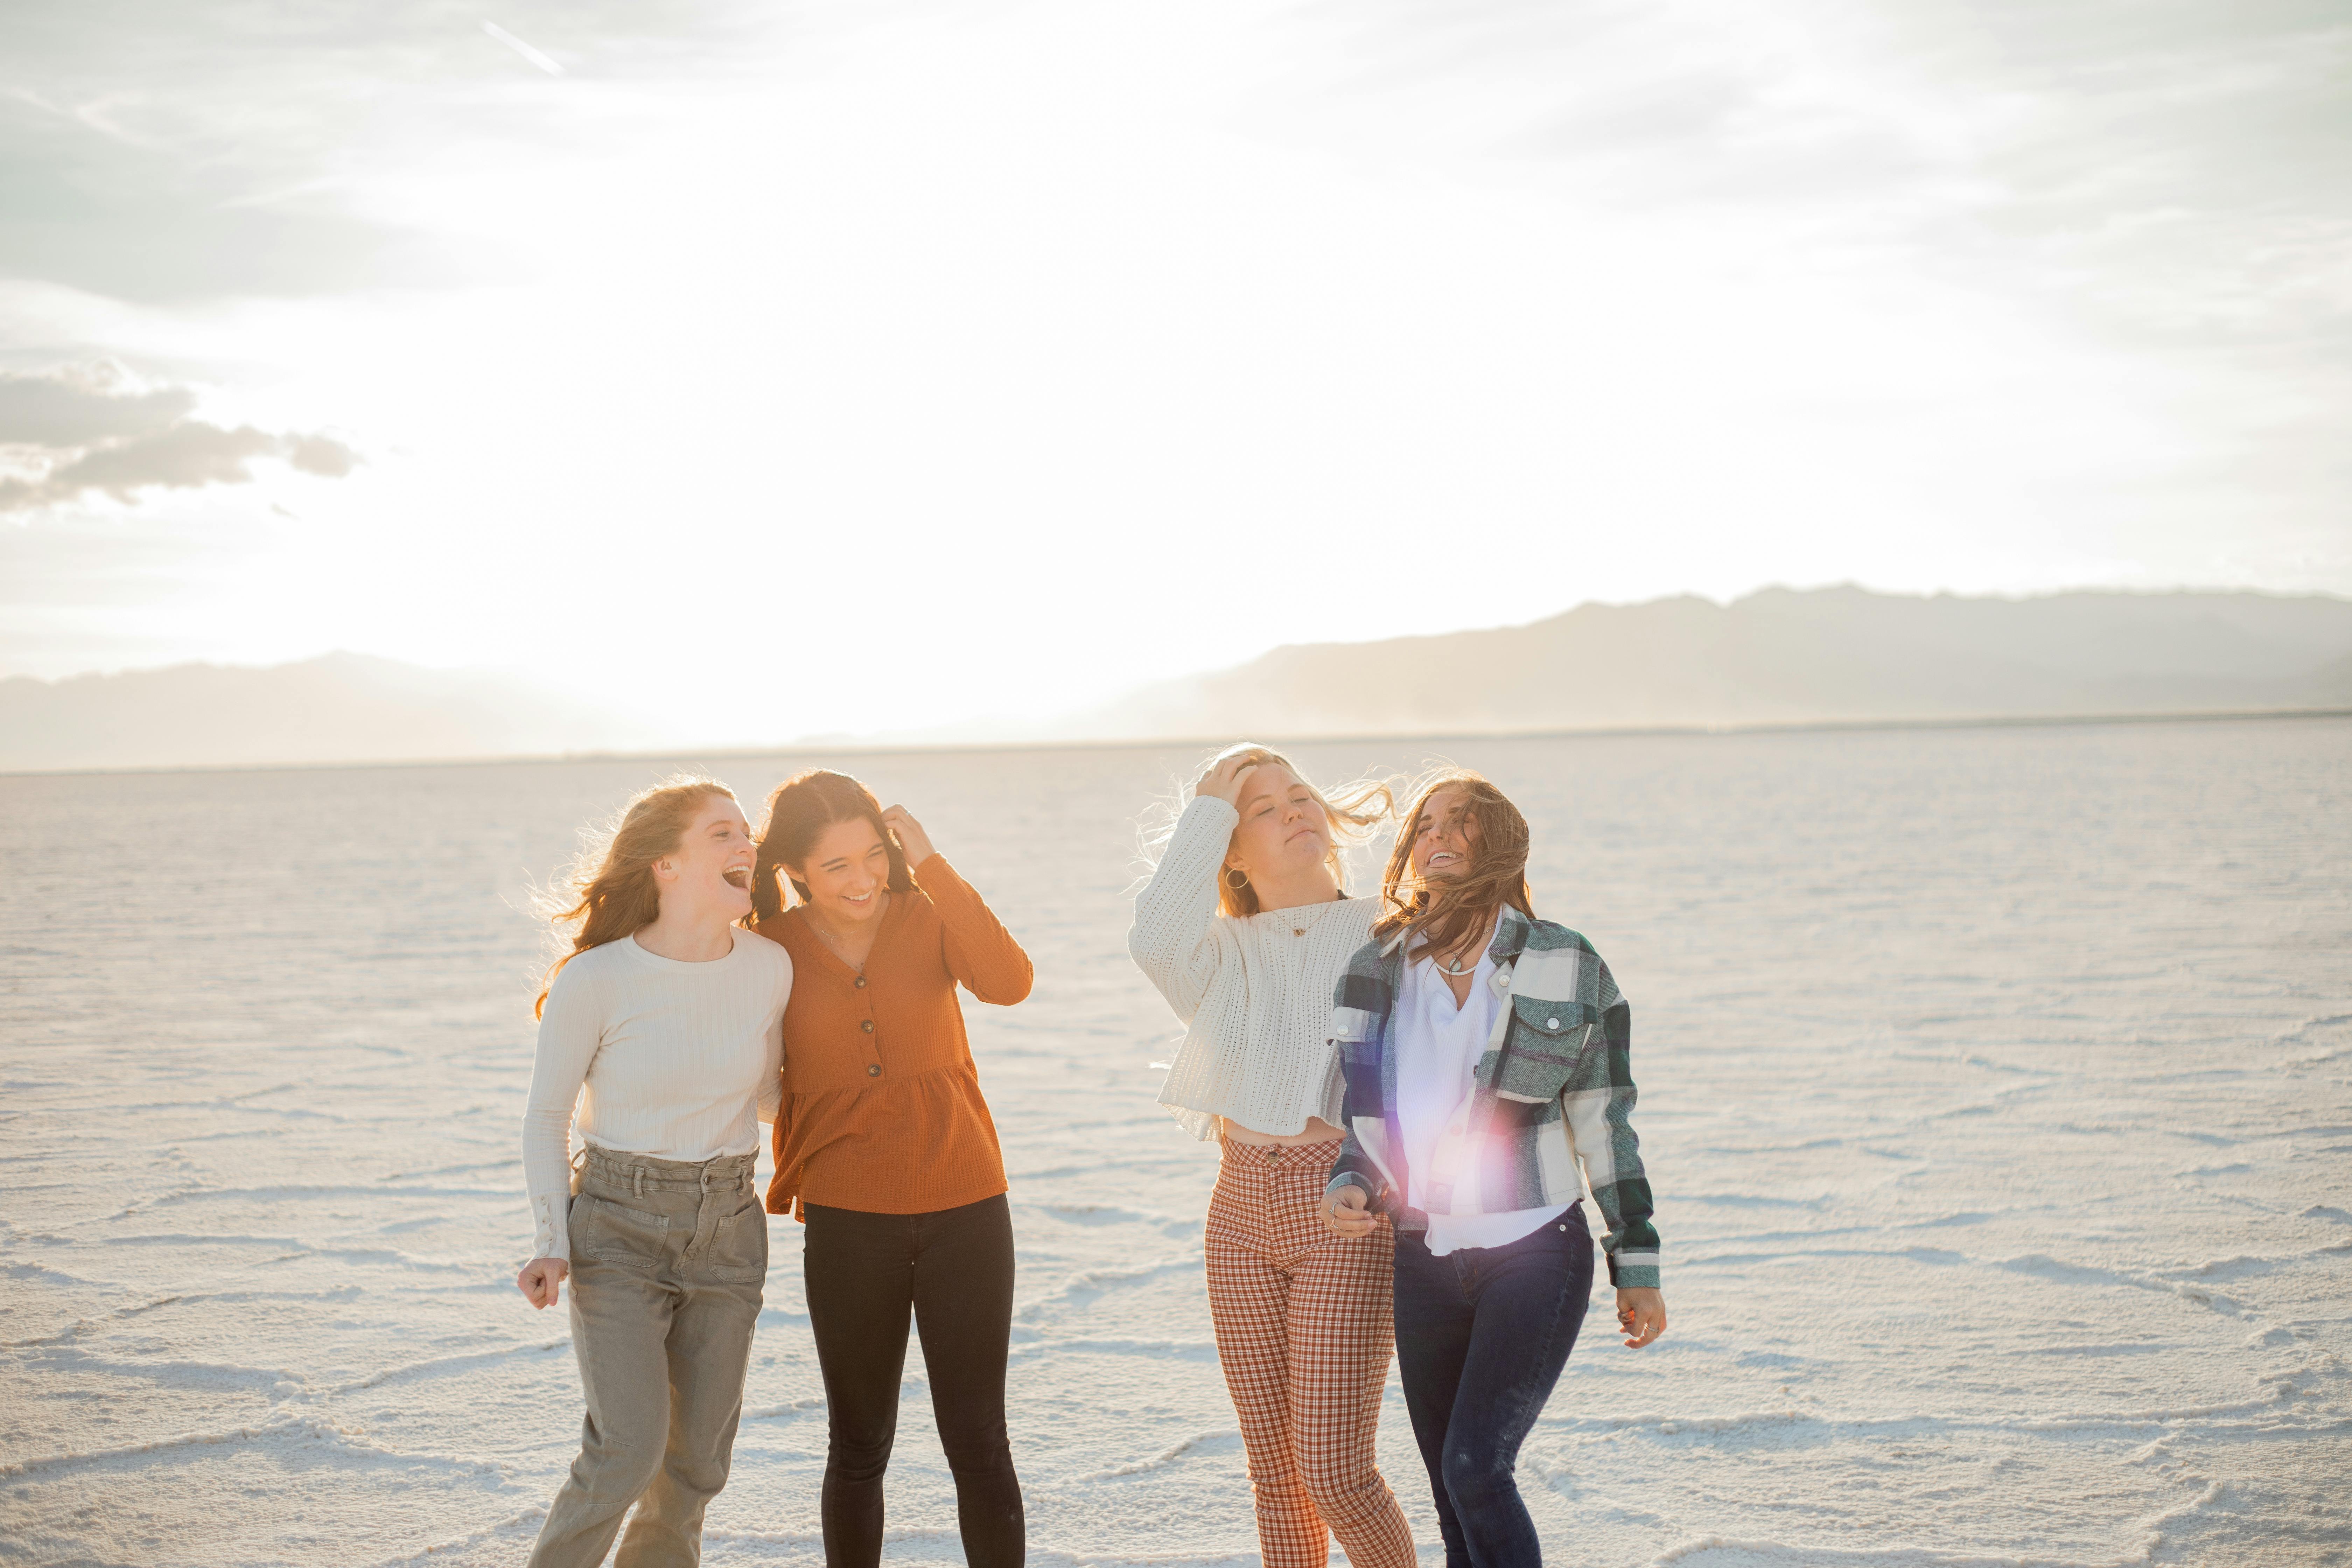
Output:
[1127,794,1378,1140]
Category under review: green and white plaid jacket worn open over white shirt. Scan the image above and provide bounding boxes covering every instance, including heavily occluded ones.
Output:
[1324,908,1658,1288]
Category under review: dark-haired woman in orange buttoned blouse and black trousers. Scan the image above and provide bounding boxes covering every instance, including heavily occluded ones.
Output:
[752,769,1030,1568]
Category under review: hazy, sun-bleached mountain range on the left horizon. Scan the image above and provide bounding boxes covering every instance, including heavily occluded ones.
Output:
[0,653,661,771]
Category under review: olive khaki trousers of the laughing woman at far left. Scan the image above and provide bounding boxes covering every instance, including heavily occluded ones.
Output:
[532,1149,767,1568]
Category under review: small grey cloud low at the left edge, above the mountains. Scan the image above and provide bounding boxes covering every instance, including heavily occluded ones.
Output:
[0,364,360,512]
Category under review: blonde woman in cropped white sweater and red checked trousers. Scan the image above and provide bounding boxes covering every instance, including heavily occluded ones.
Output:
[1127,745,1414,1568]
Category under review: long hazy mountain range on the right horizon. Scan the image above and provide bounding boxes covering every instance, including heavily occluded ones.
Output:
[1061,588,2352,738]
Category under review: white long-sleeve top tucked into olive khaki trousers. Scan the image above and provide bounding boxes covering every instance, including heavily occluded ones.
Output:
[522,931,793,1258]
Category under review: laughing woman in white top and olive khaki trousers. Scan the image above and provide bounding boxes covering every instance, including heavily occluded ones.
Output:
[515,778,793,1568]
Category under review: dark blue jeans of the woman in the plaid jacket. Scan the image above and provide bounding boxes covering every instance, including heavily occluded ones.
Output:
[1397,1204,1592,1568]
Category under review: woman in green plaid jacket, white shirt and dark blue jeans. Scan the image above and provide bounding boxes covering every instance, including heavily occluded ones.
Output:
[1322,769,1665,1568]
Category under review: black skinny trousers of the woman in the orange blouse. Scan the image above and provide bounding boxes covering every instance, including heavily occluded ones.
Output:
[802,1194,1028,1568]
